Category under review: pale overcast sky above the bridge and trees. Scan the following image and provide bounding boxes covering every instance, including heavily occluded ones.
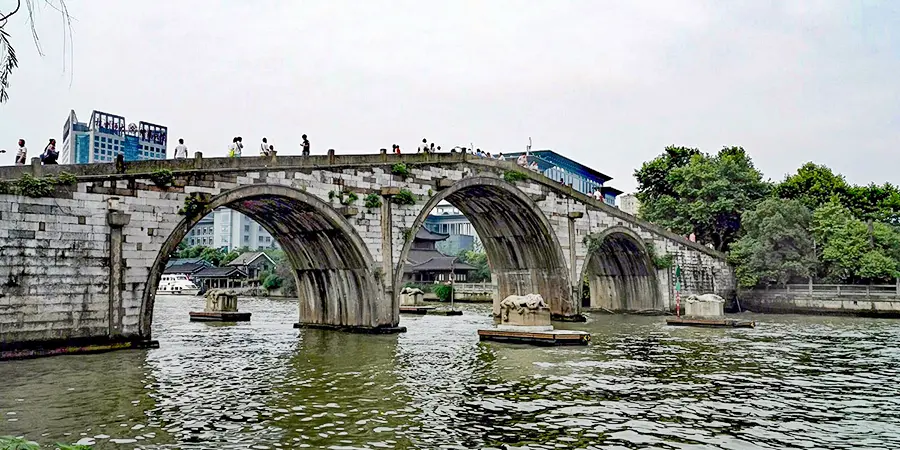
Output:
[0,0,900,191]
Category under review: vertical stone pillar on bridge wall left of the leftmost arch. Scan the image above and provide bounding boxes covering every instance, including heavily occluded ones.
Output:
[106,197,131,338]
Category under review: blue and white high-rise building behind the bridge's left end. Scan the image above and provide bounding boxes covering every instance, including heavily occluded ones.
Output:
[59,111,168,164]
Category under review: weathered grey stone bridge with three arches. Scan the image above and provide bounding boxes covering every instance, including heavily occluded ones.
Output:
[0,152,734,352]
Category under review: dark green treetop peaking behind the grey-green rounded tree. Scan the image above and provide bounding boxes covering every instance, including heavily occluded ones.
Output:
[773,162,850,210]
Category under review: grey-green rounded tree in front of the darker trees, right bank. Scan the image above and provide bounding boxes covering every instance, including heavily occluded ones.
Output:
[729,198,816,287]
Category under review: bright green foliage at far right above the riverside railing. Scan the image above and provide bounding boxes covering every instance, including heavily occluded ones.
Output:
[811,202,900,283]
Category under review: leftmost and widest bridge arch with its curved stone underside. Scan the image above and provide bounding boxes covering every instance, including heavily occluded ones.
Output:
[140,184,390,338]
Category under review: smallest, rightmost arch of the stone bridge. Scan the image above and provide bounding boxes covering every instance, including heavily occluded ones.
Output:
[580,226,665,311]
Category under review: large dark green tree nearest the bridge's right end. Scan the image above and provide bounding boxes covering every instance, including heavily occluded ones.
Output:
[635,147,771,251]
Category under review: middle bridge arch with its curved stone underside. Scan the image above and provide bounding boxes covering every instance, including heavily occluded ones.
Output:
[394,175,578,316]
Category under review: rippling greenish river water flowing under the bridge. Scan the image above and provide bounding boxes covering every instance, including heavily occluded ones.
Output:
[0,297,900,449]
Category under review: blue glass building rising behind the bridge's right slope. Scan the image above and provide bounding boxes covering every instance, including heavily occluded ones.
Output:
[503,150,622,206]
